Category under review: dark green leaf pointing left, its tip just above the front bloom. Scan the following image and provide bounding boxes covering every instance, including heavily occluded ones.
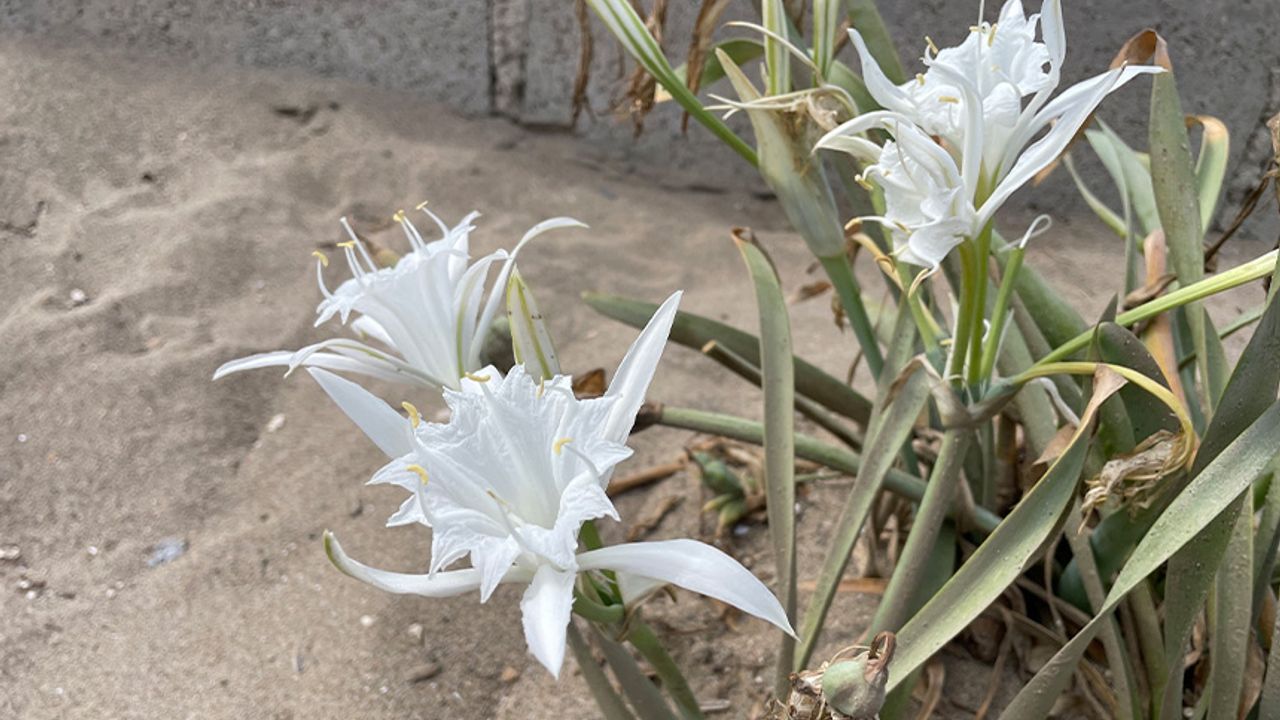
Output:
[582,292,872,427]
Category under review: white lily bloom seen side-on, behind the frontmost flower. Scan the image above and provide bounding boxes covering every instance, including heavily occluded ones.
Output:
[214,208,586,389]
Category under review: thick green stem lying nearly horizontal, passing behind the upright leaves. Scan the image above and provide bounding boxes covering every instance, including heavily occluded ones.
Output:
[653,405,1001,534]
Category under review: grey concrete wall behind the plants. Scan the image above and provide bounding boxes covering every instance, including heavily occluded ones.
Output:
[0,0,1280,240]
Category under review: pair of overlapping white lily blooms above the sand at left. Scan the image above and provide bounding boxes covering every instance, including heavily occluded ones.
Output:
[215,206,792,675]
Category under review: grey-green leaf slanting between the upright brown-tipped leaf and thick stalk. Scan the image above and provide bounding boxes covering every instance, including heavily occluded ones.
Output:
[796,304,929,669]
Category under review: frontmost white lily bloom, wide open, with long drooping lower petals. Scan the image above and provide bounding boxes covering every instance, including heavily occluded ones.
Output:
[311,293,792,676]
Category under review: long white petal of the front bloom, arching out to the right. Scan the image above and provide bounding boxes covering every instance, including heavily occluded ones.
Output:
[577,539,795,635]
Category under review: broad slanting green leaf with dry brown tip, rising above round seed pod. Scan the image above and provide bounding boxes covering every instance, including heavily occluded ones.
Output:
[890,374,1123,691]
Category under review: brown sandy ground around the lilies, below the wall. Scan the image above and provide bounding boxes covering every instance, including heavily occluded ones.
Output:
[0,37,1254,720]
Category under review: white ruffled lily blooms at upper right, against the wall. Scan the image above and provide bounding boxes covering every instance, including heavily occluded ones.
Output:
[817,0,1162,268]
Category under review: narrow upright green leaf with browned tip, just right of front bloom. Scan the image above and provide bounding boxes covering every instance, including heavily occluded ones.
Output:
[733,230,796,697]
